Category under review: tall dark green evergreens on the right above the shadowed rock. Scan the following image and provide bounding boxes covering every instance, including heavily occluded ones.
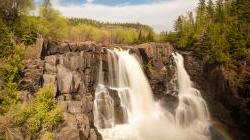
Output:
[165,0,250,63]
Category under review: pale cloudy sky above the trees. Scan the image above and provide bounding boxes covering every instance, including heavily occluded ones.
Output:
[37,0,198,32]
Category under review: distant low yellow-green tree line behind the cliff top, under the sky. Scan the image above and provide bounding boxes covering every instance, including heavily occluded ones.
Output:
[67,18,155,44]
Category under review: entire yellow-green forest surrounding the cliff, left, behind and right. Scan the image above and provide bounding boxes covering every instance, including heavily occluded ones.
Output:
[0,0,250,140]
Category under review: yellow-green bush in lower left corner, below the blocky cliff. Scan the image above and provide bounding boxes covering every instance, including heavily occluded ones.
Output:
[0,85,62,139]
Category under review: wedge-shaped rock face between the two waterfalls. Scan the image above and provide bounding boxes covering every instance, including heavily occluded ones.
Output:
[136,44,178,112]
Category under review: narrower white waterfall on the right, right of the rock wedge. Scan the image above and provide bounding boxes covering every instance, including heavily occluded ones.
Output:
[172,53,210,133]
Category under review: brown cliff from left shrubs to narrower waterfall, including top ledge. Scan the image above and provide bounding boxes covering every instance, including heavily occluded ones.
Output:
[19,41,176,140]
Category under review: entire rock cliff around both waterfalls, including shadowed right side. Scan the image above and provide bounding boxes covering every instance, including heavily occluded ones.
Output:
[19,41,250,140]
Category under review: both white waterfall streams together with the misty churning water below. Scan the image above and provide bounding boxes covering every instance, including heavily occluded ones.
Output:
[94,50,210,140]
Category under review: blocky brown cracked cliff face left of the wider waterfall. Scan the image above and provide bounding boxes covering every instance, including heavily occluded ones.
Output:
[43,51,98,140]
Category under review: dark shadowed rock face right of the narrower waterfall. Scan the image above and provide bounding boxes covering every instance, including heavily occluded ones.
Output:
[180,52,250,140]
